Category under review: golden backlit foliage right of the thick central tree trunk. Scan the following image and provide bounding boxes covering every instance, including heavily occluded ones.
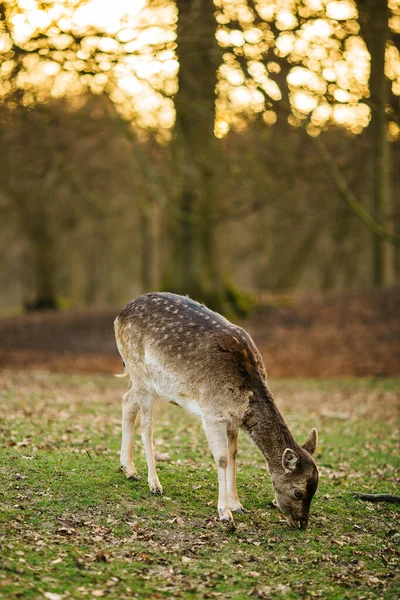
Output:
[216,0,400,136]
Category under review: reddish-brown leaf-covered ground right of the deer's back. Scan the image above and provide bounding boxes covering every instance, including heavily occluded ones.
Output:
[248,288,400,377]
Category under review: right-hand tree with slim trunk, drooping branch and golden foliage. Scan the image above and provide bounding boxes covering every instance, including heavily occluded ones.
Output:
[217,0,400,285]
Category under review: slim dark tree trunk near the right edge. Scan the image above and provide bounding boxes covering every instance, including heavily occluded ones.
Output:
[358,0,395,287]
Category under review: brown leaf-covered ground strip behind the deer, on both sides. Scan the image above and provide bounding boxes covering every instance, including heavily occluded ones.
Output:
[0,288,400,378]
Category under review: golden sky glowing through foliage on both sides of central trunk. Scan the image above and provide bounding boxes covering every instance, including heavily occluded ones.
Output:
[0,0,400,137]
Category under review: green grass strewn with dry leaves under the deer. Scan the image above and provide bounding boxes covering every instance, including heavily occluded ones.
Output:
[0,371,400,600]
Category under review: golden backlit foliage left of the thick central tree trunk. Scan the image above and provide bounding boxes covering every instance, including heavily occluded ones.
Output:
[0,0,177,140]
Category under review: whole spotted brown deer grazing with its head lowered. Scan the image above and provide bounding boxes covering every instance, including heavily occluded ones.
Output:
[114,293,318,529]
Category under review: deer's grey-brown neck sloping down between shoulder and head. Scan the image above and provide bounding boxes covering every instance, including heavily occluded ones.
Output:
[241,385,298,473]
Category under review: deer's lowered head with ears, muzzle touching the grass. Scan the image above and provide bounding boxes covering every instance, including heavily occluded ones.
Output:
[271,429,318,529]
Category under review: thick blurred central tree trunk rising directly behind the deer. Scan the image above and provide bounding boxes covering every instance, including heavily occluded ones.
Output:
[168,0,225,308]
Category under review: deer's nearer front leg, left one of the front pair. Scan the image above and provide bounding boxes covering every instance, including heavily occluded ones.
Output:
[203,419,233,522]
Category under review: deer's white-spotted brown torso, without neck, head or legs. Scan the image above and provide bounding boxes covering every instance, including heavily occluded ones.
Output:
[115,292,266,412]
